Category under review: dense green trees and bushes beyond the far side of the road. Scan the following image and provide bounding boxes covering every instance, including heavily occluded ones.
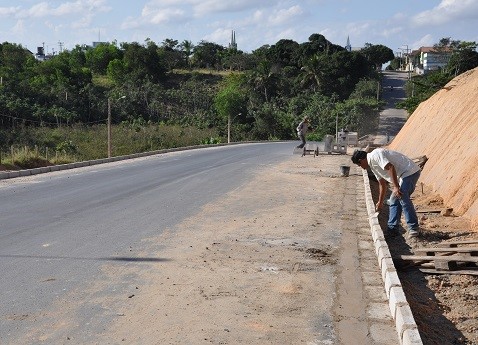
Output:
[0,34,394,167]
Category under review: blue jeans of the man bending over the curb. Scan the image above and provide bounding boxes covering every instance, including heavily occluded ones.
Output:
[387,171,420,230]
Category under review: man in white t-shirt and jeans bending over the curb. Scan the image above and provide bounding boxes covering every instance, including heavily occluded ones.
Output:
[352,148,421,237]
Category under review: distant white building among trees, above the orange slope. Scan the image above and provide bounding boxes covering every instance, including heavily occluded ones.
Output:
[410,47,452,74]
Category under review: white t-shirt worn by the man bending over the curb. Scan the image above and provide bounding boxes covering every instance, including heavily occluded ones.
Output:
[367,148,420,184]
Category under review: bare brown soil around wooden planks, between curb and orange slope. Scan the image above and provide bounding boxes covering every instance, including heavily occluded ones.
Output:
[371,181,478,345]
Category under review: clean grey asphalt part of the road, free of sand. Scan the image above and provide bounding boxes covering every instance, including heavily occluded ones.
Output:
[0,143,293,343]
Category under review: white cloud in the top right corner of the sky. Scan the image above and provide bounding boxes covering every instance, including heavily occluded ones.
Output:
[411,0,478,26]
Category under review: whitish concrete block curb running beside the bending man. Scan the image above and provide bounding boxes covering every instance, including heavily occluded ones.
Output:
[362,170,423,345]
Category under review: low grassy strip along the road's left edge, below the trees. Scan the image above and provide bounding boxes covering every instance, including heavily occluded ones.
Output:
[0,123,224,170]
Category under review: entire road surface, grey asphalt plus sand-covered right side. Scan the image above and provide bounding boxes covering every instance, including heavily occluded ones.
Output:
[0,143,398,345]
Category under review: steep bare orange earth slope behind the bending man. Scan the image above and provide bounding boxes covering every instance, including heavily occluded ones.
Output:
[389,68,478,229]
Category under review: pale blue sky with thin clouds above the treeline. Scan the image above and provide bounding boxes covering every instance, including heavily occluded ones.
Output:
[0,0,478,53]
